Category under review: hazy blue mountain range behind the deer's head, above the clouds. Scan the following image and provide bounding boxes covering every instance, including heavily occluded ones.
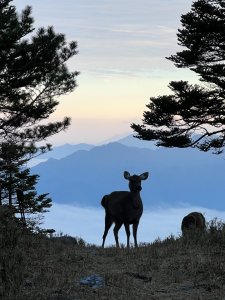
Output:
[31,138,225,210]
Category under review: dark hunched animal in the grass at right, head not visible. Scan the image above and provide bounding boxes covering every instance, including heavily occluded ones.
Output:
[181,212,206,235]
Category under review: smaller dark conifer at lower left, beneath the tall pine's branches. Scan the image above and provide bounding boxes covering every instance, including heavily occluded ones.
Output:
[0,143,52,225]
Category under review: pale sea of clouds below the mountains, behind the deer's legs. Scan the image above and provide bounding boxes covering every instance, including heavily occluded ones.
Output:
[43,204,225,246]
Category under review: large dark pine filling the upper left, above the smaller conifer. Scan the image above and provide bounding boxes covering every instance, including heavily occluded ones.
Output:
[0,0,78,147]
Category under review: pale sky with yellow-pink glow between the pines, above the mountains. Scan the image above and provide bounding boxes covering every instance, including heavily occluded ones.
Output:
[12,0,197,146]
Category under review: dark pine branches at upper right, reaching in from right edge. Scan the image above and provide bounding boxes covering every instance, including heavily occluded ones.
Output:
[131,0,225,154]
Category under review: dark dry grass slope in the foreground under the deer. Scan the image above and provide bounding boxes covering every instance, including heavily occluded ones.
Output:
[0,210,225,300]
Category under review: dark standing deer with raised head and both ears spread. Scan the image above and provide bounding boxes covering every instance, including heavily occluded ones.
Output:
[101,171,149,248]
